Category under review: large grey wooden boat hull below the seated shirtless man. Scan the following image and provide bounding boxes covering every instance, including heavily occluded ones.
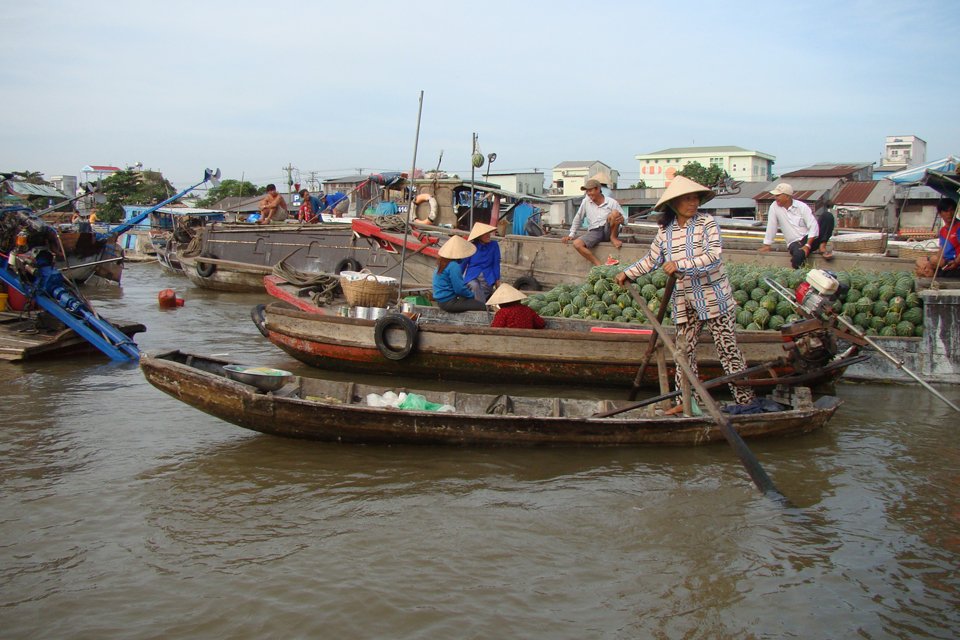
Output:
[178,223,434,292]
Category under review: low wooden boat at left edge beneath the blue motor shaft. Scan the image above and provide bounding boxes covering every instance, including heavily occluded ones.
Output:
[0,312,146,362]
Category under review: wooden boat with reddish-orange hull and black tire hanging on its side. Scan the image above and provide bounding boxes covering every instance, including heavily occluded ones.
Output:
[253,302,859,387]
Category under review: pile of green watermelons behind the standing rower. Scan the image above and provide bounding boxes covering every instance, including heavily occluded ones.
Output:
[524,263,923,337]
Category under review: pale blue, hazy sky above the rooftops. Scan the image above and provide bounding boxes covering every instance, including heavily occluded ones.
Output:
[0,0,960,194]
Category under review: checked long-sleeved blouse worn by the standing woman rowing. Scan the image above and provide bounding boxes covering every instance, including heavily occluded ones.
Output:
[624,212,736,324]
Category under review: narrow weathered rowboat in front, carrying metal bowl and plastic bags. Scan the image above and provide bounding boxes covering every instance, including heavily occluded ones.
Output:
[140,351,840,446]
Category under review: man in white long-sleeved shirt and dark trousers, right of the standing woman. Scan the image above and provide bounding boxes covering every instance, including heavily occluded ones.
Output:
[758,182,833,269]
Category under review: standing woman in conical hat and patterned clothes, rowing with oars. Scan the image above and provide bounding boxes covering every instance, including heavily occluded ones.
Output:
[617,176,756,415]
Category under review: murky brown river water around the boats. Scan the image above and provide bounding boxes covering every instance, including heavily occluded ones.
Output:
[0,264,960,639]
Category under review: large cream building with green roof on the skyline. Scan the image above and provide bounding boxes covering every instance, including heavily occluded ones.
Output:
[634,146,776,189]
